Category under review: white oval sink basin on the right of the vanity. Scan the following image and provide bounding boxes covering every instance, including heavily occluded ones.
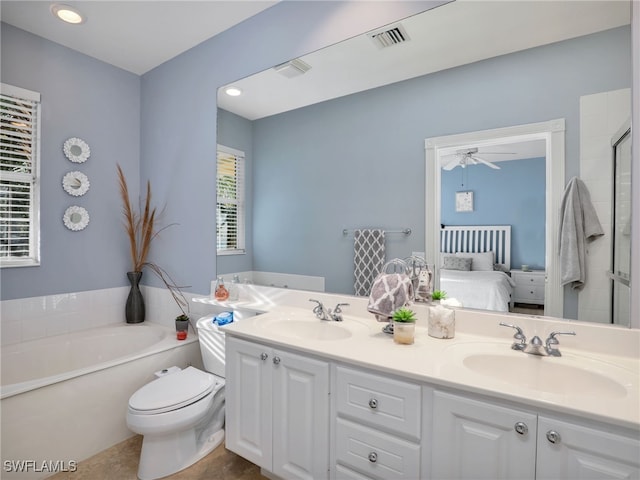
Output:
[449,343,638,398]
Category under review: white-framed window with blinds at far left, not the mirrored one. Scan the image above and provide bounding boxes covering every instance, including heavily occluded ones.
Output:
[0,83,40,267]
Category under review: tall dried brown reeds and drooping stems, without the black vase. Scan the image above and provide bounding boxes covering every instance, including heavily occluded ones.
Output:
[117,164,189,318]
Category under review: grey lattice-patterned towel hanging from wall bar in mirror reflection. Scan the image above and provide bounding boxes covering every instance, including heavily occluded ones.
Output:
[353,229,385,297]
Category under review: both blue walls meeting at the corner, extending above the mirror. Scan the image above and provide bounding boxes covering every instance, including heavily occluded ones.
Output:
[0,1,436,300]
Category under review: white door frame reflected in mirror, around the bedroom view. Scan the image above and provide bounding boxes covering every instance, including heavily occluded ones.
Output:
[425,118,565,318]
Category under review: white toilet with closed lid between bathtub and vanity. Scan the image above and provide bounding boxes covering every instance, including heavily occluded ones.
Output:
[127,316,225,480]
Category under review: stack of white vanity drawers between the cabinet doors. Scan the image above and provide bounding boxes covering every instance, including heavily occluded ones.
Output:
[332,365,422,480]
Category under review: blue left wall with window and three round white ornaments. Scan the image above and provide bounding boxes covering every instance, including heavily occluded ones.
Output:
[1,23,140,300]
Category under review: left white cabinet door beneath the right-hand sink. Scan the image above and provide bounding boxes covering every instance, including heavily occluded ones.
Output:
[431,392,536,480]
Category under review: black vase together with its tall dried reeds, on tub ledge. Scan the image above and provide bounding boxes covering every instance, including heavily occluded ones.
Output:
[117,165,189,331]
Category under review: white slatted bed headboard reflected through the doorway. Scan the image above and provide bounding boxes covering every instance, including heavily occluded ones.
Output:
[440,225,511,271]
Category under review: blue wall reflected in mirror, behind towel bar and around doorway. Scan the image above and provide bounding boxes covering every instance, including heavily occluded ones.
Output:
[245,27,631,296]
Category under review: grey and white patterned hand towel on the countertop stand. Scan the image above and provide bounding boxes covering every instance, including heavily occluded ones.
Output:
[367,273,413,322]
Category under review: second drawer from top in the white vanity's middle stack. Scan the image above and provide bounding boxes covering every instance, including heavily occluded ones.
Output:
[336,418,420,480]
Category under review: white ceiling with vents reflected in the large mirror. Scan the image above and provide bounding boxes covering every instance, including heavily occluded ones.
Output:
[218,0,631,120]
